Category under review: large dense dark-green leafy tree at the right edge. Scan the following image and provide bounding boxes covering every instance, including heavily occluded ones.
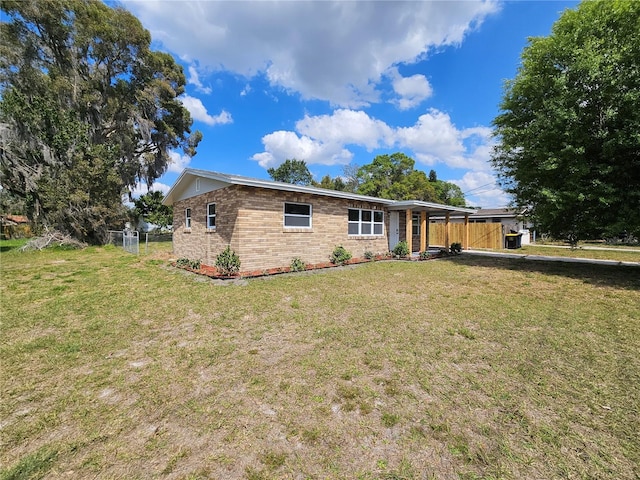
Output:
[492,0,640,242]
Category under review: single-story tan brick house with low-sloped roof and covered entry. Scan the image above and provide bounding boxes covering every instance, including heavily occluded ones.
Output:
[164,168,475,271]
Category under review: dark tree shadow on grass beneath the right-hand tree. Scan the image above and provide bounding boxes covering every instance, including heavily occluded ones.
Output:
[443,254,640,290]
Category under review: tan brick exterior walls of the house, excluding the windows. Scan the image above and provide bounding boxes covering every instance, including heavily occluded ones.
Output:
[173,185,389,271]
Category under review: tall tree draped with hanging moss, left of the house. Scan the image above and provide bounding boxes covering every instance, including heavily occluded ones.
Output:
[0,0,201,243]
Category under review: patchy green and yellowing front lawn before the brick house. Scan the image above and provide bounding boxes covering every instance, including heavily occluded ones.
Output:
[0,242,640,479]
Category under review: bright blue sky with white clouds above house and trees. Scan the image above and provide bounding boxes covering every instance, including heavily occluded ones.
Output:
[122,0,578,208]
